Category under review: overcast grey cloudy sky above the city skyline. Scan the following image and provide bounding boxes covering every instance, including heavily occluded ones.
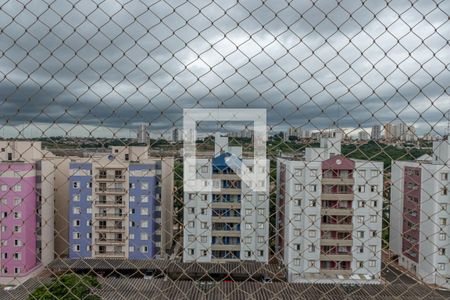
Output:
[0,0,450,137]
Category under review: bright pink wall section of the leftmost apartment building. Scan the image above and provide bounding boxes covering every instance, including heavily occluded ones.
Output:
[0,162,38,277]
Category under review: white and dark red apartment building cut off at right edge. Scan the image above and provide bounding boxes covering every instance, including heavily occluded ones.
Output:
[389,139,450,288]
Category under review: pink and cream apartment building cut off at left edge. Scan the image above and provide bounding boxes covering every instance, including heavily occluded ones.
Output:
[0,140,58,284]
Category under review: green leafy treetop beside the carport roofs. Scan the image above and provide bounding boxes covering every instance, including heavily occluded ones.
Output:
[28,273,100,300]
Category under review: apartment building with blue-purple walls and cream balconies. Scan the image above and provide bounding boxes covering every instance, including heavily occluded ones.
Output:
[69,147,173,259]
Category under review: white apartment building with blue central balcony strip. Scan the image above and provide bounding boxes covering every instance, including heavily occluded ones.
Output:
[183,134,269,262]
